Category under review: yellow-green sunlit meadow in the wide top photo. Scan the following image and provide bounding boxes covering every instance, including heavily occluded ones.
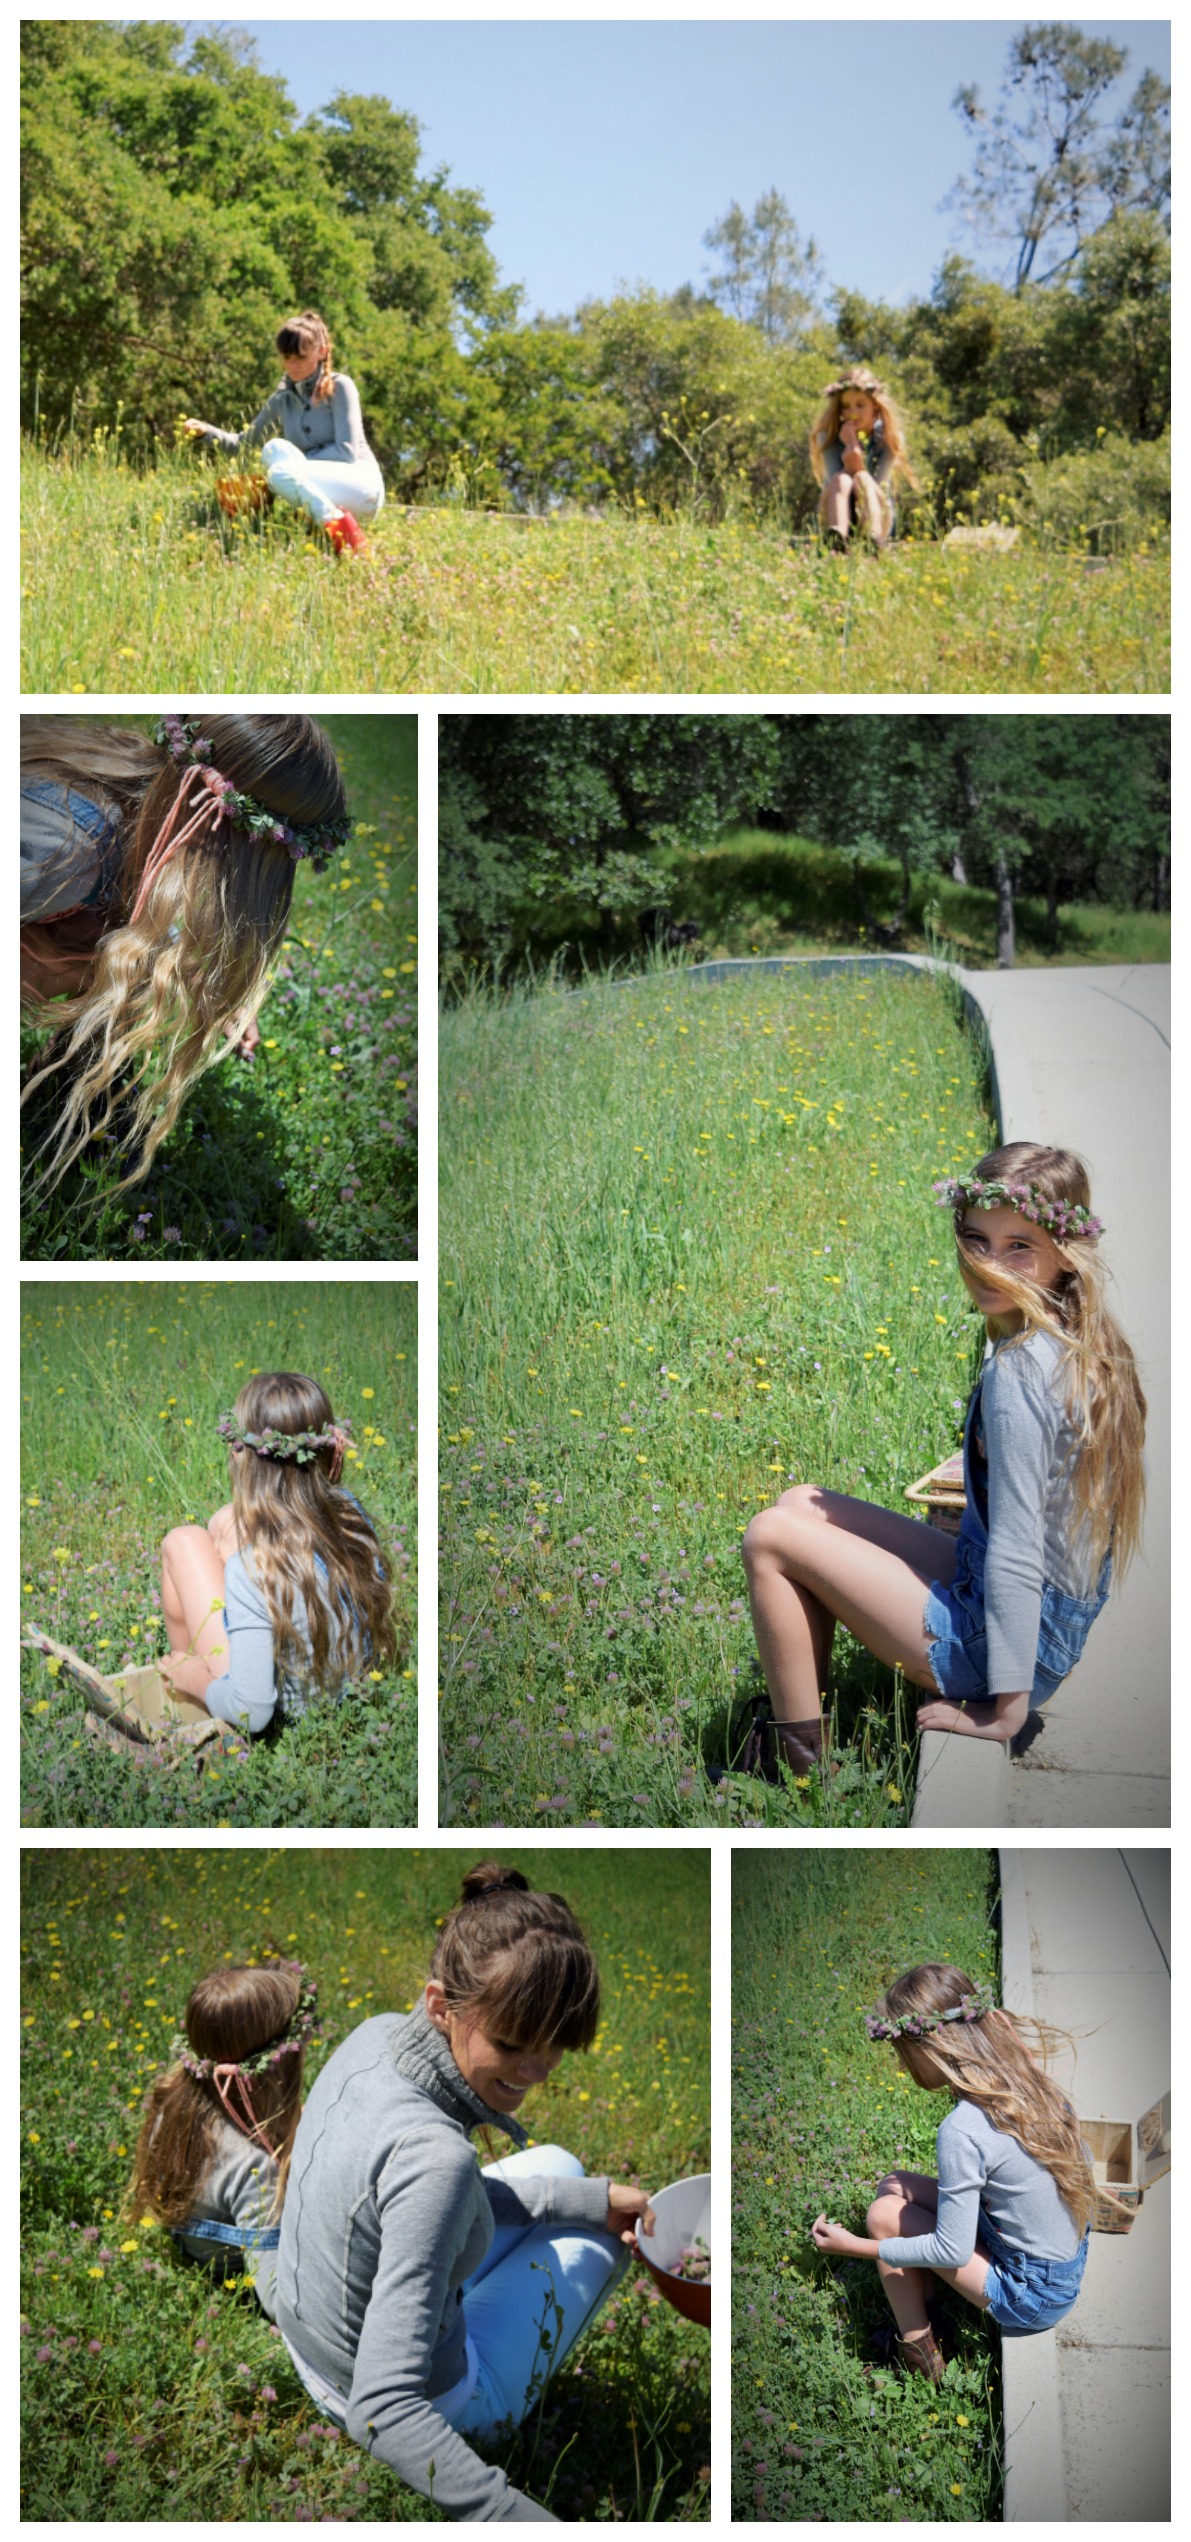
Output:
[20,437,1171,697]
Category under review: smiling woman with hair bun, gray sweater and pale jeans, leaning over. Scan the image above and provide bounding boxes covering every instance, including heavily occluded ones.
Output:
[277,1863,653,2524]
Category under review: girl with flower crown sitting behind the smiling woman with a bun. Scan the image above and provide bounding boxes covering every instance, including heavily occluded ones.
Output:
[124,1960,317,2318]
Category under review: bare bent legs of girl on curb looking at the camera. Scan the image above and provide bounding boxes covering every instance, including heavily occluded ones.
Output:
[744,1482,955,1721]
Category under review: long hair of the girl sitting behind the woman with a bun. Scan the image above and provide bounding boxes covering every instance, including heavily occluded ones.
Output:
[124,1962,305,2227]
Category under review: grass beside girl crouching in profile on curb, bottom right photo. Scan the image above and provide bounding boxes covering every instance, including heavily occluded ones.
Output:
[731,1848,1001,2524]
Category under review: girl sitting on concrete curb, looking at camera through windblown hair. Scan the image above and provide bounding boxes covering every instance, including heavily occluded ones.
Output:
[744,1139,1145,1782]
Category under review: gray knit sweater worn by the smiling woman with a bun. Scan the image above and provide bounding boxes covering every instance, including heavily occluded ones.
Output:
[277,2003,607,2524]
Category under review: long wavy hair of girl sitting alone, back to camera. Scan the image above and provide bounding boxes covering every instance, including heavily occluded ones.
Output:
[231,1370,396,1688]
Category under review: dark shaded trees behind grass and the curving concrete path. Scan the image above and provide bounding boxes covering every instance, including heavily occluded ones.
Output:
[439,712,1171,979]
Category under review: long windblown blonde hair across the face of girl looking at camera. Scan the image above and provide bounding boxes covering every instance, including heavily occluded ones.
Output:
[955,1139,1145,1581]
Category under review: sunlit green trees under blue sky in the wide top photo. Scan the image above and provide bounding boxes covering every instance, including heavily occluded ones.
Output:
[23,18,1171,547]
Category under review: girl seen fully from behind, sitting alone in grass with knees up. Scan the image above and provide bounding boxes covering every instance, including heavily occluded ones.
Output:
[157,1373,396,1731]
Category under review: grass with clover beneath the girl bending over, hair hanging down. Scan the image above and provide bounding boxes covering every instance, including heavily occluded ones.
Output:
[20,706,416,1263]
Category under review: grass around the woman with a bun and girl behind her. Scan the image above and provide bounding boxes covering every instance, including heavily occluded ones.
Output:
[20,1845,711,2524]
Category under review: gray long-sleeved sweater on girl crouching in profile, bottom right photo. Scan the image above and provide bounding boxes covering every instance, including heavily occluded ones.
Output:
[881,2100,1079,2267]
